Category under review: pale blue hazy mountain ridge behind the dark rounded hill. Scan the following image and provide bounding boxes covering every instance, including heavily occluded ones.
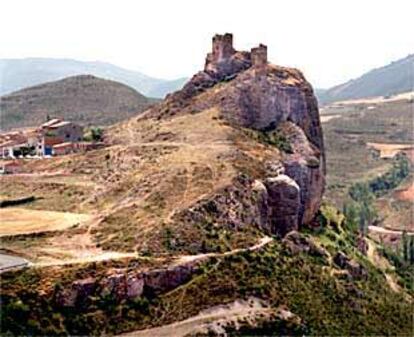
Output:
[0,58,185,98]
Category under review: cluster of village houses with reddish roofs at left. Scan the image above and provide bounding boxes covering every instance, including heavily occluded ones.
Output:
[0,118,103,174]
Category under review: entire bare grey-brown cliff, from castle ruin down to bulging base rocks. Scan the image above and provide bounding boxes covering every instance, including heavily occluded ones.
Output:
[148,34,325,236]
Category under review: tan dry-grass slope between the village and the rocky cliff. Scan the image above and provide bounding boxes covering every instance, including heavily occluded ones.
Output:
[1,108,279,263]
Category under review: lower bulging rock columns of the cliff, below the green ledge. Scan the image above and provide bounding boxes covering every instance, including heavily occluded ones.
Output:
[247,122,325,237]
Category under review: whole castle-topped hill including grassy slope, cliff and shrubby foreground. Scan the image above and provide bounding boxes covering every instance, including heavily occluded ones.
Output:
[1,34,412,336]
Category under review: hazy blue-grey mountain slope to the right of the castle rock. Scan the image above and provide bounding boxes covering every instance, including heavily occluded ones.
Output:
[316,54,414,103]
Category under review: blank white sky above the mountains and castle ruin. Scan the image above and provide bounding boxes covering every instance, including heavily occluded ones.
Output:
[0,0,414,88]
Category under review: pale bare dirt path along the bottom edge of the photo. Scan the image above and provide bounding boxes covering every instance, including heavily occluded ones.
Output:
[119,298,272,337]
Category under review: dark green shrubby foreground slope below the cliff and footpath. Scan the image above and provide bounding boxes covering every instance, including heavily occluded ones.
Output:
[1,207,413,336]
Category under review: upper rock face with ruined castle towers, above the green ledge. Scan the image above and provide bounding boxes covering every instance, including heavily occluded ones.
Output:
[149,34,323,152]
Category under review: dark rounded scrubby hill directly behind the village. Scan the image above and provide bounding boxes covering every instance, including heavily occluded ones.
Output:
[0,75,154,130]
